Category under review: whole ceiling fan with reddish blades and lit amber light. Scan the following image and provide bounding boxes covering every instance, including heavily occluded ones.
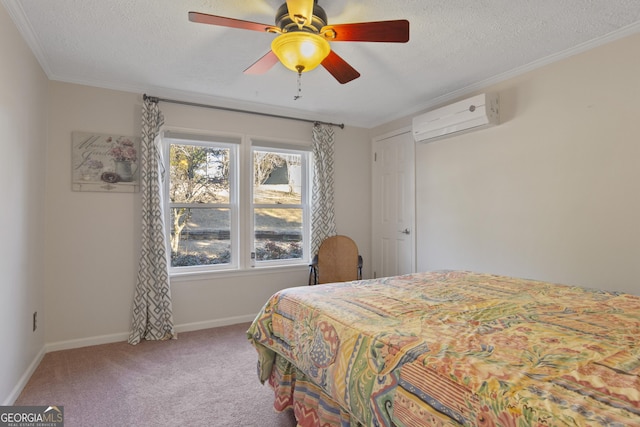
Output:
[189,0,409,84]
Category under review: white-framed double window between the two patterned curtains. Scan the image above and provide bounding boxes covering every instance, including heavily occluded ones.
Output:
[163,132,310,274]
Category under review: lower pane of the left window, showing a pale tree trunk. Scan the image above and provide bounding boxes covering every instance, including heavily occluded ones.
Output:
[170,208,231,267]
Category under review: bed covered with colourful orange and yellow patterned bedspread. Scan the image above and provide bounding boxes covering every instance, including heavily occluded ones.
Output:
[247,271,640,427]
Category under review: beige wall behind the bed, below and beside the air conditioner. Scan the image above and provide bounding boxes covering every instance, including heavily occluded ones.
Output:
[373,34,640,294]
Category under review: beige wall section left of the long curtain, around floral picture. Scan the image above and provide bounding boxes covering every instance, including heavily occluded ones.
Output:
[45,82,141,343]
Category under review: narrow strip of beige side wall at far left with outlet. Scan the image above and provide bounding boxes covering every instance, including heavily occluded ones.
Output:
[0,7,47,405]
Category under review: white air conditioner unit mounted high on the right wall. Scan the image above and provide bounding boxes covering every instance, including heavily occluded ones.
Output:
[413,93,500,142]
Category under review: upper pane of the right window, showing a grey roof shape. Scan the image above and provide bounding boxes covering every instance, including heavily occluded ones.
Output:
[253,150,302,205]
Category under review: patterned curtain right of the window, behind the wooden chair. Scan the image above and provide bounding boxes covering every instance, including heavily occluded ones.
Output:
[311,123,337,256]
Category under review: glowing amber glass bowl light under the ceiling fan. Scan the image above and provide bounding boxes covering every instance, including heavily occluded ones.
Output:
[271,32,331,73]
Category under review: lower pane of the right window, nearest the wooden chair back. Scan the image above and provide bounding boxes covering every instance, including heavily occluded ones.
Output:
[254,208,303,261]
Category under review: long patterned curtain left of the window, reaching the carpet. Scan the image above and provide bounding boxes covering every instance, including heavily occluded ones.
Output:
[129,96,177,344]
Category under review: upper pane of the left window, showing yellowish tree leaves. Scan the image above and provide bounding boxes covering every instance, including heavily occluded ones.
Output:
[169,144,230,203]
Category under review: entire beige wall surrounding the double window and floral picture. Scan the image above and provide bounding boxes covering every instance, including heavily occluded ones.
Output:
[46,82,371,348]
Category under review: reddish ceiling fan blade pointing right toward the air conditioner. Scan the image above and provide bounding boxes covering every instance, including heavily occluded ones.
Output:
[321,19,409,43]
